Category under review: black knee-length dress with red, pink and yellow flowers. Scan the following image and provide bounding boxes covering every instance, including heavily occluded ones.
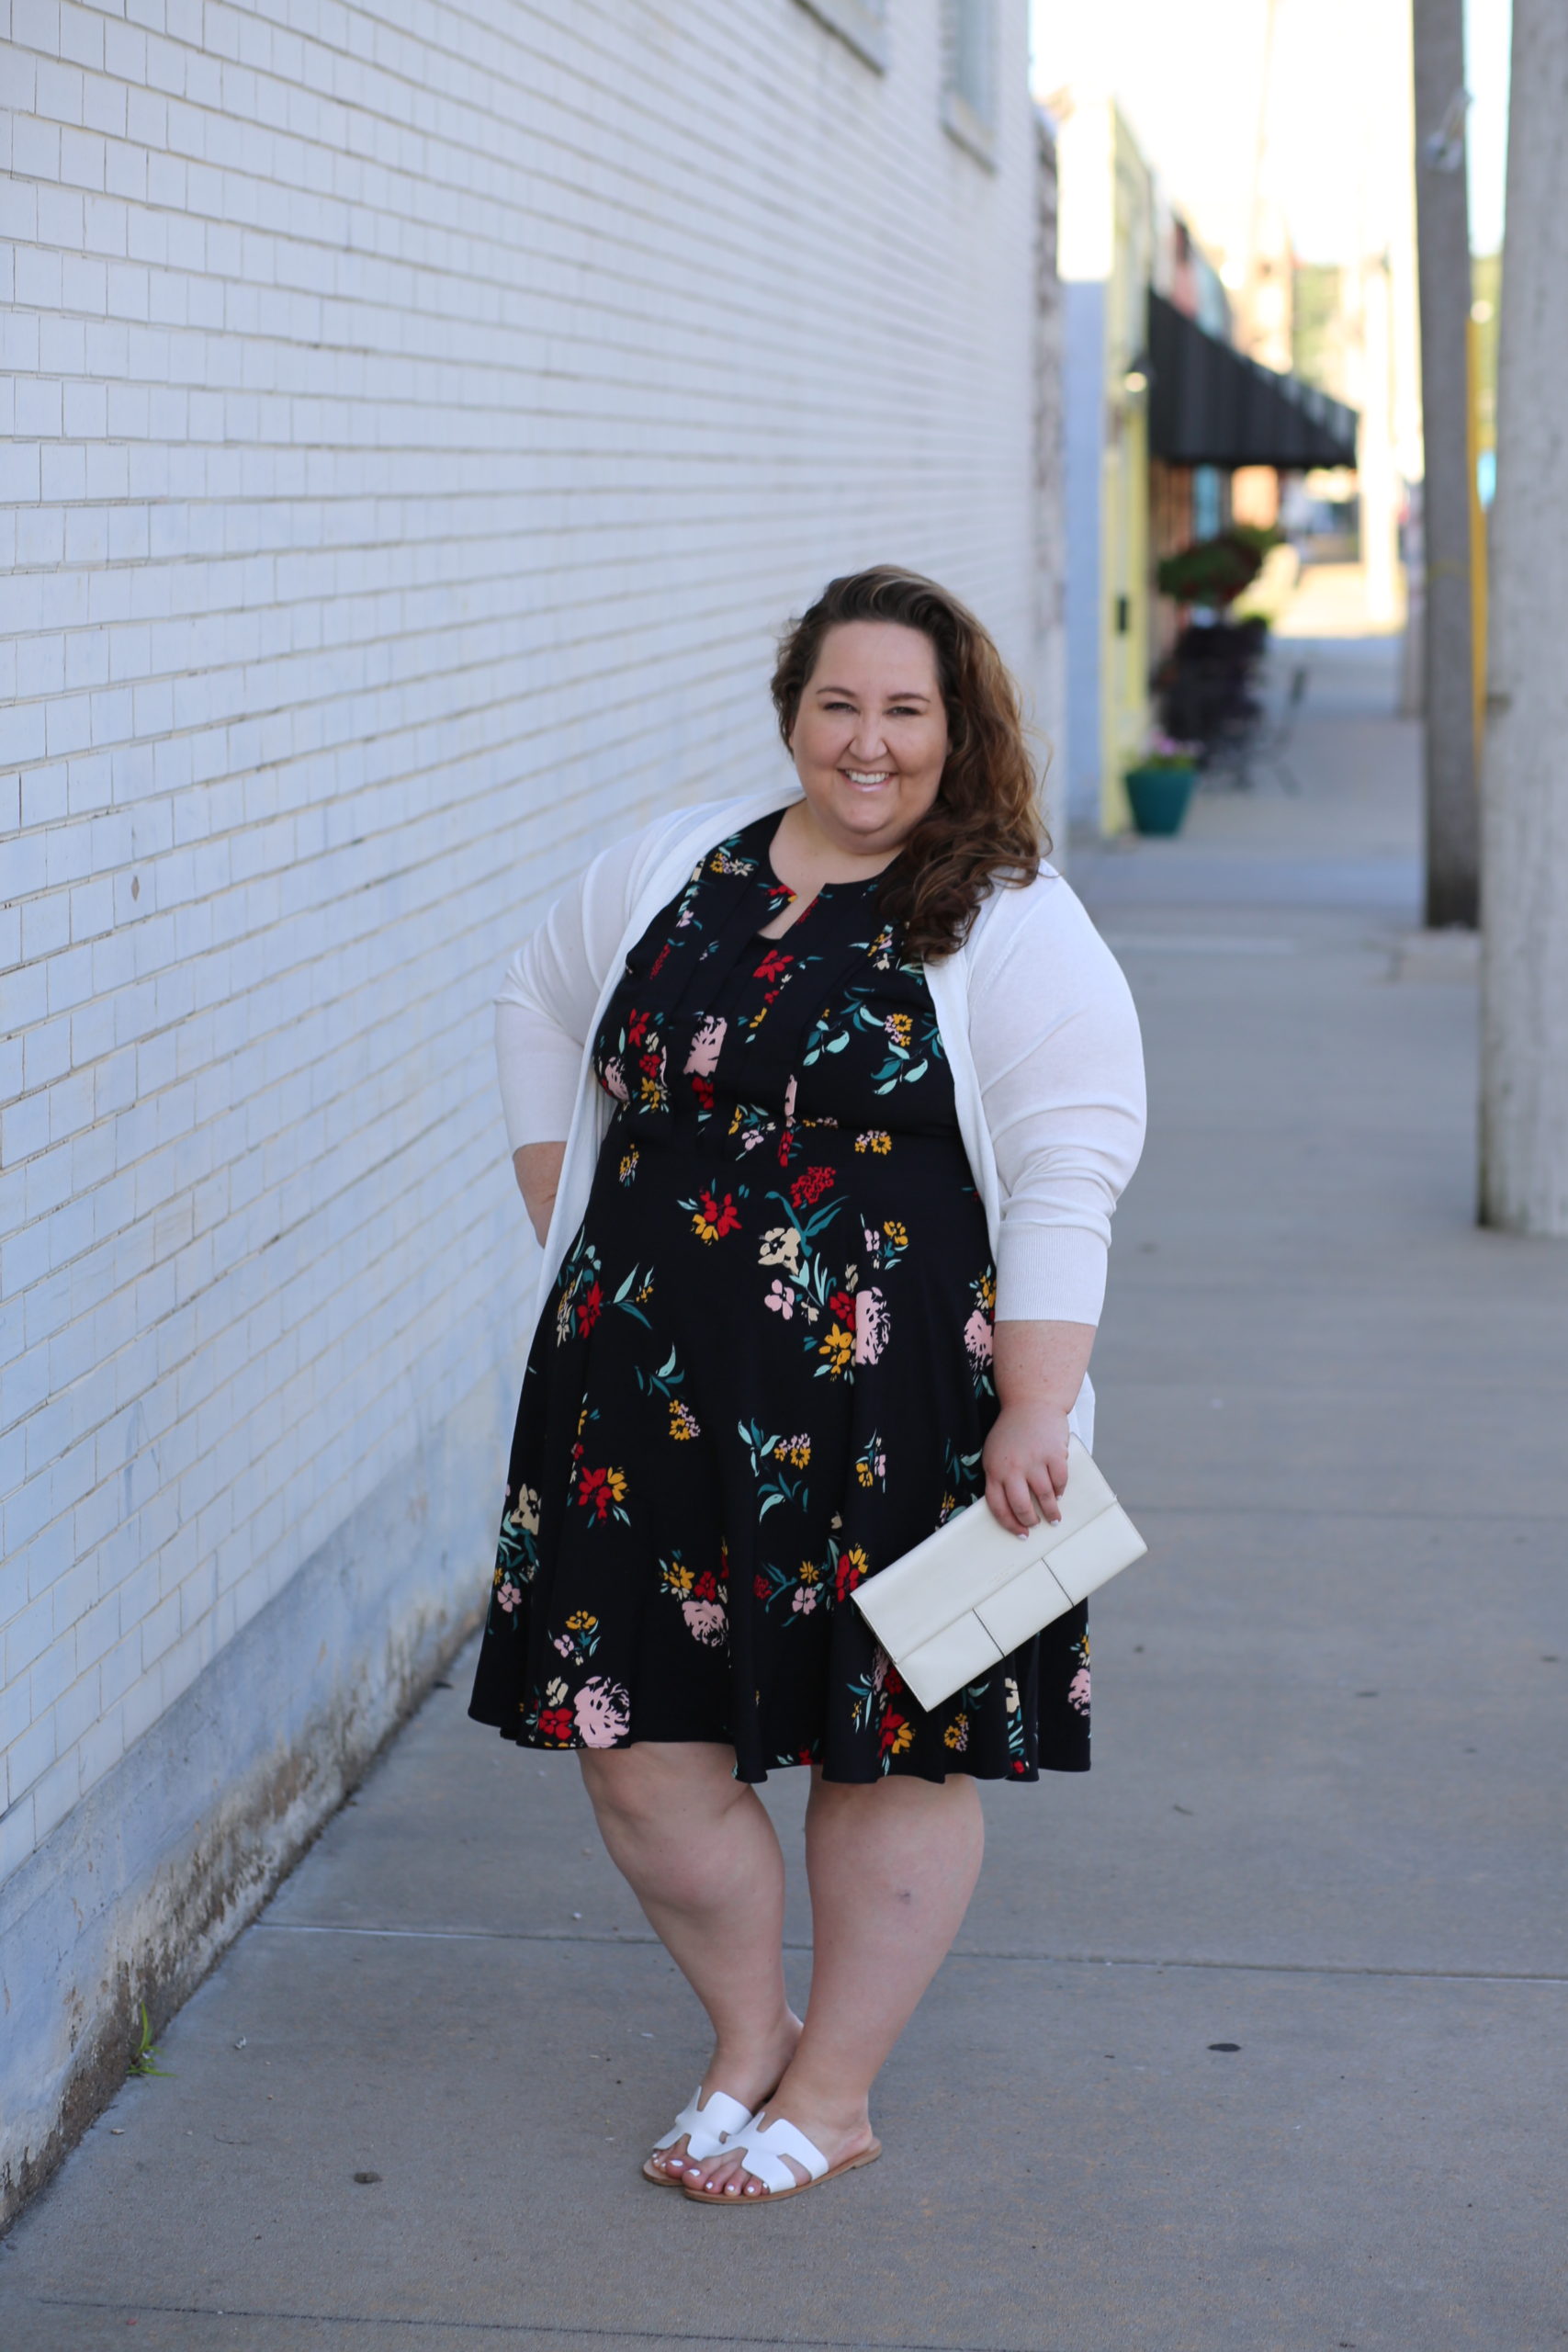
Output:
[470,816,1089,1781]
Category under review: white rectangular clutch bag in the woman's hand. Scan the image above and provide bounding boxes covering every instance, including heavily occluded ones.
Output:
[853,1437,1147,1708]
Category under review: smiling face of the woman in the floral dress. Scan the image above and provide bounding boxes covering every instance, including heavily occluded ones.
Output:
[790,621,947,856]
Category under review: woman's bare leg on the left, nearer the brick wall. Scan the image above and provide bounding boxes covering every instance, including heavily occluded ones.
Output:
[581,1740,799,2178]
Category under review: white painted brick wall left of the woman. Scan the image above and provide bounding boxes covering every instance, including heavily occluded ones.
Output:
[0,0,1042,1874]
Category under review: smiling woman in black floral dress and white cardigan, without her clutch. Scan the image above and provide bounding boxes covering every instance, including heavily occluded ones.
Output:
[470,567,1143,2204]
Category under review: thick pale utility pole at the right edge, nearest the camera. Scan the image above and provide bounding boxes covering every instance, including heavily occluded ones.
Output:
[1481,0,1568,1235]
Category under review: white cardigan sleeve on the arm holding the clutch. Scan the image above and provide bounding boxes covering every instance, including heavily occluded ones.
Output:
[968,875,1145,1324]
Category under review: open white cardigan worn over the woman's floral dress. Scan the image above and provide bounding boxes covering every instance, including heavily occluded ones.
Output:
[496,781,1145,1444]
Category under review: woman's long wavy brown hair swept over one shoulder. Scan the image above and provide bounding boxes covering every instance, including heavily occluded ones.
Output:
[773,564,1051,955]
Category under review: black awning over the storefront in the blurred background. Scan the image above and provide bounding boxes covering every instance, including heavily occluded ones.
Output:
[1149,294,1357,473]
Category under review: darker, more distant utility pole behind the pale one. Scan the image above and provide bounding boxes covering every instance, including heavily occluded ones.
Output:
[1413,0,1481,929]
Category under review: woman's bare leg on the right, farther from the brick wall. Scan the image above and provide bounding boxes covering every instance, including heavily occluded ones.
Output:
[686,1773,985,2197]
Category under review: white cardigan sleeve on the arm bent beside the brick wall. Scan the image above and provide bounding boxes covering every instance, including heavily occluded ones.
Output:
[496,828,662,1152]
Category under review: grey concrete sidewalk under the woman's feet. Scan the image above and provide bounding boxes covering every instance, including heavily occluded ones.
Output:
[0,639,1568,2352]
